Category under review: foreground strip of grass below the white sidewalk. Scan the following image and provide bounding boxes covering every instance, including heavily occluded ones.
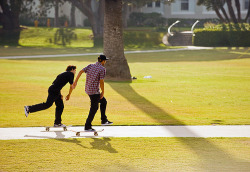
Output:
[0,138,250,171]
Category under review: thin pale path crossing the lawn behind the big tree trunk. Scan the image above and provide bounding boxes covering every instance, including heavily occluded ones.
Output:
[0,46,212,59]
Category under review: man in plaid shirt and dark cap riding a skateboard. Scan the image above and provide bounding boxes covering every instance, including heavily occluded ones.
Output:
[73,55,113,131]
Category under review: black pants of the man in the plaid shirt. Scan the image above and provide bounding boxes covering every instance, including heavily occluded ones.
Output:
[85,94,107,129]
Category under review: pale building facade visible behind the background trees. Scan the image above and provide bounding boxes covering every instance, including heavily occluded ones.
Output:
[37,0,250,27]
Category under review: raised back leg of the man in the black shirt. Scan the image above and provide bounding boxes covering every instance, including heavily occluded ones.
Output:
[29,93,57,113]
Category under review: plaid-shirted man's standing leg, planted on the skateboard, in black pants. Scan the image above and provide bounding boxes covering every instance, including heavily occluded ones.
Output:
[85,94,100,129]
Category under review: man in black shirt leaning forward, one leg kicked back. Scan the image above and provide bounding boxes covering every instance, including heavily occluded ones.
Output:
[24,65,76,127]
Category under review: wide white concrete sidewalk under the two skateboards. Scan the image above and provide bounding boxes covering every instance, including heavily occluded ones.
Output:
[0,125,250,140]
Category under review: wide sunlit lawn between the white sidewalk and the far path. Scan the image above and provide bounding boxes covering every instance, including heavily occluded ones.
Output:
[0,49,250,127]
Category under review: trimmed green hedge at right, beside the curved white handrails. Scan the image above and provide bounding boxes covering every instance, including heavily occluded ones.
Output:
[193,24,250,47]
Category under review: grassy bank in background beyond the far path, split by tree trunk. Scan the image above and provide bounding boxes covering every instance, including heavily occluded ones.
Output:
[1,27,169,51]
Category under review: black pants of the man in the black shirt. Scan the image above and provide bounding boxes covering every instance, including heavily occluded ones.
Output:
[29,88,64,124]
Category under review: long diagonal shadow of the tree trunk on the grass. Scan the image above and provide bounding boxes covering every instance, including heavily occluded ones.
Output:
[108,82,250,171]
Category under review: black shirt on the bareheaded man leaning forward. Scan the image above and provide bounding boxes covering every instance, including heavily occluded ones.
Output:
[50,72,74,91]
